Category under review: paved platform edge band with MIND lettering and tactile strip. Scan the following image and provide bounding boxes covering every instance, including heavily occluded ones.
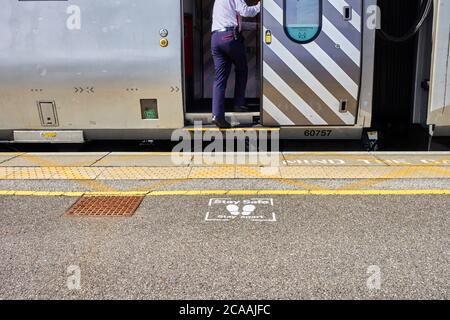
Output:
[0,152,450,180]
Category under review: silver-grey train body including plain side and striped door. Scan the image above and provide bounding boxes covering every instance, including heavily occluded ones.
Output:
[0,0,450,142]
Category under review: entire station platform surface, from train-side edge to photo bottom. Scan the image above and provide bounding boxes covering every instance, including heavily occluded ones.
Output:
[0,152,450,299]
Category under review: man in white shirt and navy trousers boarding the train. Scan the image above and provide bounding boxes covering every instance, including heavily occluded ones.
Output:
[211,0,261,128]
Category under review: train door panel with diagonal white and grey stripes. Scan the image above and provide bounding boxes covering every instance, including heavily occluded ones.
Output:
[262,0,363,126]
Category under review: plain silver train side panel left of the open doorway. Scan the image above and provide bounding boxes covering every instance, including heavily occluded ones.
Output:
[0,0,184,138]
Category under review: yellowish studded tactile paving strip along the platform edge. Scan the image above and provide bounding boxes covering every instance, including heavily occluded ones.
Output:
[0,166,450,181]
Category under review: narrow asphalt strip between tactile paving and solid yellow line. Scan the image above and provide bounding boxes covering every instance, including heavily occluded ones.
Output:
[0,179,450,192]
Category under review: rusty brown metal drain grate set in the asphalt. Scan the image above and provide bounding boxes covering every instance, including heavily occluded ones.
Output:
[66,196,144,217]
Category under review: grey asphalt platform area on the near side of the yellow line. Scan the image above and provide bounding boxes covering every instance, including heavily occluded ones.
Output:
[0,192,450,299]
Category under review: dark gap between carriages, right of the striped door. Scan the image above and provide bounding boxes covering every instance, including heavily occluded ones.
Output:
[373,0,433,144]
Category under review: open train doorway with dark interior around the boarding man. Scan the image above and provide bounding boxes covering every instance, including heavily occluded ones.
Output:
[183,0,261,123]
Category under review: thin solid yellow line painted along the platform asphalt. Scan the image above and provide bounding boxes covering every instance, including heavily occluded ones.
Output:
[0,189,450,197]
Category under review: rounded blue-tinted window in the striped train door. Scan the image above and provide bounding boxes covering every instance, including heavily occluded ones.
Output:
[284,0,322,44]
